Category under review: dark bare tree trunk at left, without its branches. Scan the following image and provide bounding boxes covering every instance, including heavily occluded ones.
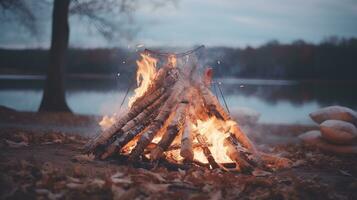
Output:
[39,0,71,112]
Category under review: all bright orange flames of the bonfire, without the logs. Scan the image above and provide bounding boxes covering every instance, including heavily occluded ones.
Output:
[99,54,235,163]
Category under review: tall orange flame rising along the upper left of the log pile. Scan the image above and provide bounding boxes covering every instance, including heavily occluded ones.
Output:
[128,54,157,108]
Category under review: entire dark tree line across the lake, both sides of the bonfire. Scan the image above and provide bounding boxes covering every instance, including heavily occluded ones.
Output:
[0,37,357,80]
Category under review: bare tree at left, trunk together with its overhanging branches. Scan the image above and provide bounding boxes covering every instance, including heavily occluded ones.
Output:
[0,0,175,112]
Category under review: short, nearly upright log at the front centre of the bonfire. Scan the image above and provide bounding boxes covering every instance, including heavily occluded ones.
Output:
[180,116,193,161]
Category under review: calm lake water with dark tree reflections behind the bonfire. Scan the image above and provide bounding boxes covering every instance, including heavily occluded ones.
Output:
[0,76,357,124]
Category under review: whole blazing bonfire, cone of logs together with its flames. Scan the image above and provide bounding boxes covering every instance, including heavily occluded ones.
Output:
[85,46,289,173]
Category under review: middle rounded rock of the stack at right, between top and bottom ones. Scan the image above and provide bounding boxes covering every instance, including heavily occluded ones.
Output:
[320,120,357,144]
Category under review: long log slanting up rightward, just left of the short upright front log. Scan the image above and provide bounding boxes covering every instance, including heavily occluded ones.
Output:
[151,100,188,160]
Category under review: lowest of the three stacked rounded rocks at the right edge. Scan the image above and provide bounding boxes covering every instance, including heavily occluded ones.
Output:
[299,130,357,154]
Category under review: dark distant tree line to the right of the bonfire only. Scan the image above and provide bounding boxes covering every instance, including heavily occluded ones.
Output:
[210,37,357,80]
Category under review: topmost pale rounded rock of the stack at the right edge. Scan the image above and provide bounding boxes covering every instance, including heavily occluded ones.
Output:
[310,106,357,125]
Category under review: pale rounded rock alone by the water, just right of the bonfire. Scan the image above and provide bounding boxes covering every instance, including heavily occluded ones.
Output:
[230,107,260,124]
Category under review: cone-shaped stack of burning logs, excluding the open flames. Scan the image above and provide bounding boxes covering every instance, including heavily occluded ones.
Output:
[85,54,289,172]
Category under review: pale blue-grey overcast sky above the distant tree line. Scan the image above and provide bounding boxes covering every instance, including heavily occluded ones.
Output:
[0,0,357,48]
